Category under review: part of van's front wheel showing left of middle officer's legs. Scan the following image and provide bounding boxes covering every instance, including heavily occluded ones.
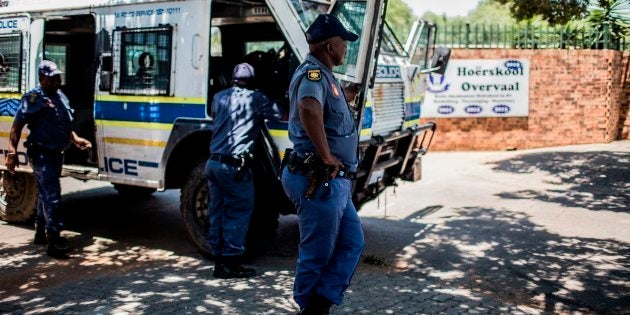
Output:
[180,160,211,257]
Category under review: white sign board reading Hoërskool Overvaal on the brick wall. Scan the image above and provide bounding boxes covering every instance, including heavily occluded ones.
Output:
[422,59,529,118]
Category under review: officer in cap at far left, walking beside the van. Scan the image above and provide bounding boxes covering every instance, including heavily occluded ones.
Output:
[6,60,92,258]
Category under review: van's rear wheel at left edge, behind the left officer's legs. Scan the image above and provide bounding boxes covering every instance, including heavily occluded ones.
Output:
[0,171,37,223]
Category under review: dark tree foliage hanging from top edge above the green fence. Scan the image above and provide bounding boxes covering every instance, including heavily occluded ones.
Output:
[494,0,589,25]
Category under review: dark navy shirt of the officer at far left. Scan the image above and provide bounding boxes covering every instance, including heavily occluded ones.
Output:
[15,86,72,152]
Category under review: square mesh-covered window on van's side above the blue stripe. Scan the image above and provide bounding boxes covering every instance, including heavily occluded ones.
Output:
[113,27,173,95]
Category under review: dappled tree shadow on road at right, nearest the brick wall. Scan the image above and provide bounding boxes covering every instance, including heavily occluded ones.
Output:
[493,152,630,213]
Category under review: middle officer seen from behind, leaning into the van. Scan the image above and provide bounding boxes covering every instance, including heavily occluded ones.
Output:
[205,63,281,278]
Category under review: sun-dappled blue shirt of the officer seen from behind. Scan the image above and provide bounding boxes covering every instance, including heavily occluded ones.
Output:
[210,87,281,157]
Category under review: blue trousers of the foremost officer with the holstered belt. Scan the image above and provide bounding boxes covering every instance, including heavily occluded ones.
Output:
[282,168,365,308]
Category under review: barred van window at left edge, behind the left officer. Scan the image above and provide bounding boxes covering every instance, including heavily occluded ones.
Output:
[0,33,22,92]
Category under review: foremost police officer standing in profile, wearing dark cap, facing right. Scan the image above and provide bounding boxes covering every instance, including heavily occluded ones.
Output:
[282,14,365,314]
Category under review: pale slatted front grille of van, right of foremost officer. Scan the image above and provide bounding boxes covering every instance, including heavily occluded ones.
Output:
[372,83,405,136]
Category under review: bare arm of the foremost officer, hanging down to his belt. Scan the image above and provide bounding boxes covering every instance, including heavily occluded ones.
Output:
[298,97,339,172]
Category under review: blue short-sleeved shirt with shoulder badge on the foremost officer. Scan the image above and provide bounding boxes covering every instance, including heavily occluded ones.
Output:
[289,54,359,171]
